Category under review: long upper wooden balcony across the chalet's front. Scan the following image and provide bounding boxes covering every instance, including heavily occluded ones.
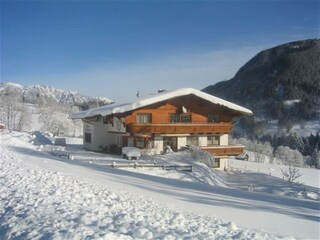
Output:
[126,123,232,134]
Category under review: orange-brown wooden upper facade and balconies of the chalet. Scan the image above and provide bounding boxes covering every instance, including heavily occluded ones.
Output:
[121,96,244,161]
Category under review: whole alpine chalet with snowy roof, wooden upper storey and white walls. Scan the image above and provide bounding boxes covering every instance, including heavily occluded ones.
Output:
[71,88,252,169]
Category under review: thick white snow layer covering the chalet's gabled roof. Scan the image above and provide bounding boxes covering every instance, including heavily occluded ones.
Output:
[71,88,252,119]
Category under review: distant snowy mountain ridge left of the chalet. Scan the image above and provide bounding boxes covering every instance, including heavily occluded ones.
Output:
[0,83,113,109]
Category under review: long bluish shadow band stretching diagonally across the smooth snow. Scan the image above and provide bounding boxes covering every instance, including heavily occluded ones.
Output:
[12,146,320,222]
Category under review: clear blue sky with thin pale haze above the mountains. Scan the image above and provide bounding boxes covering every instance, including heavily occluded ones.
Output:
[0,0,320,102]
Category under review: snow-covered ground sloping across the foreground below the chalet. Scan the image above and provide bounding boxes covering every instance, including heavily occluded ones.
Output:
[0,133,320,239]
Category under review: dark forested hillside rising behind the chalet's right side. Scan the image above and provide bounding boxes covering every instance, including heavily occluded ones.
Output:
[203,39,320,120]
